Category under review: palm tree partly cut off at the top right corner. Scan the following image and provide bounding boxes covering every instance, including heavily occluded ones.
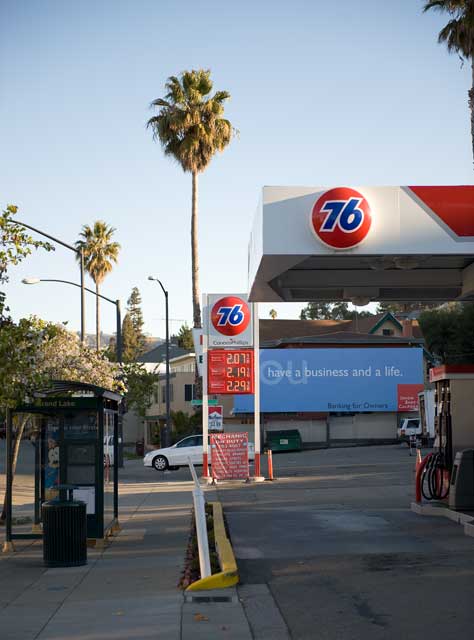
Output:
[423,0,474,165]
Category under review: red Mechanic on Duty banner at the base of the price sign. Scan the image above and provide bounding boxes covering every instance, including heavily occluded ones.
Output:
[211,432,249,480]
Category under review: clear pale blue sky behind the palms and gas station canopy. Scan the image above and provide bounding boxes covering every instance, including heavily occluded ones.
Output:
[0,0,473,335]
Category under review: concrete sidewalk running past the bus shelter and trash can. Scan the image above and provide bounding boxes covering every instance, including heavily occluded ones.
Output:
[0,461,251,640]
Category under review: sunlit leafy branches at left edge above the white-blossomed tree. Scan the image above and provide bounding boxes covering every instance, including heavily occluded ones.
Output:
[0,204,54,321]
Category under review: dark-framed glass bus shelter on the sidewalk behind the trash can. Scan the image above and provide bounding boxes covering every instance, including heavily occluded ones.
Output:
[5,381,122,550]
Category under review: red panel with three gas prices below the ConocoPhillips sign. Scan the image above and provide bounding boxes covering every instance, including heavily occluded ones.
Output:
[207,349,254,395]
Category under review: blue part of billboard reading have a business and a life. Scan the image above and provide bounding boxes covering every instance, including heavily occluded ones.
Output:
[234,347,423,413]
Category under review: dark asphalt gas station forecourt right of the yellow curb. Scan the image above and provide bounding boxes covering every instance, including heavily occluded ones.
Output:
[218,446,474,640]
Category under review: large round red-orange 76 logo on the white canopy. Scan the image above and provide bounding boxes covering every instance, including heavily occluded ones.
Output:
[310,187,372,249]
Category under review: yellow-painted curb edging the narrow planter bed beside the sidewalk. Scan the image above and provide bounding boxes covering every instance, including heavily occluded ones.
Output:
[186,502,239,591]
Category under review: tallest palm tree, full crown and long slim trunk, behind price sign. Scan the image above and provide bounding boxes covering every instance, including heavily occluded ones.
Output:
[147,69,234,327]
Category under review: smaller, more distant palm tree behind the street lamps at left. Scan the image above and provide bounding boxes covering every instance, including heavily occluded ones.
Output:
[76,220,120,351]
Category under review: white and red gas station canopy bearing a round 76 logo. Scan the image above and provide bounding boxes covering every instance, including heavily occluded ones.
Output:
[249,186,474,305]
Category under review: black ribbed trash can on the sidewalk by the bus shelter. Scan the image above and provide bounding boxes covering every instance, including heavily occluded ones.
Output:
[42,500,87,567]
